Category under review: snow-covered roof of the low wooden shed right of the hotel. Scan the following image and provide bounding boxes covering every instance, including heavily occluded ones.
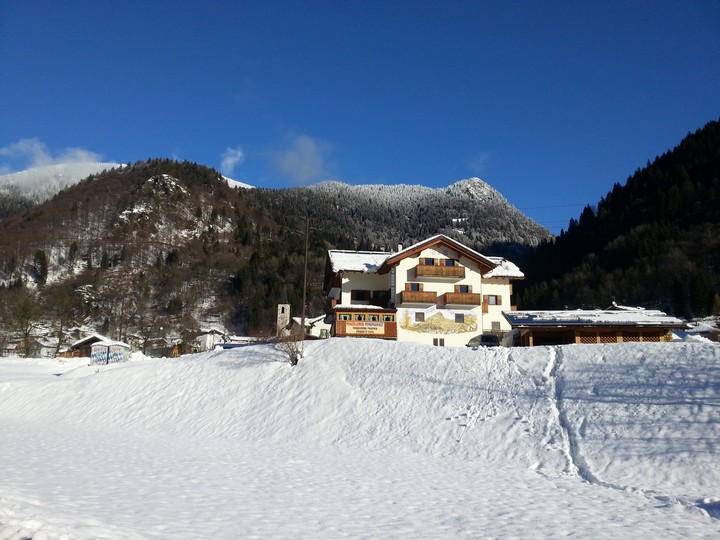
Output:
[503,308,687,328]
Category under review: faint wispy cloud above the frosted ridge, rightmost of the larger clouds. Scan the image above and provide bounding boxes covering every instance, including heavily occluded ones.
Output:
[272,134,333,184]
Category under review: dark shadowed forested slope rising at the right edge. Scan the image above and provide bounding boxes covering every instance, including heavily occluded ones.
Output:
[519,116,720,317]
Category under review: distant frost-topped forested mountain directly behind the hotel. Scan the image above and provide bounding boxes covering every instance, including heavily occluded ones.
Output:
[258,178,551,257]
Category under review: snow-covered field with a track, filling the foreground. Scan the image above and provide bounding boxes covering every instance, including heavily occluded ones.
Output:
[0,339,720,539]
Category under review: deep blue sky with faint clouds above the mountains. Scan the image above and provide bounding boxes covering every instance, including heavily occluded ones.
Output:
[0,0,720,233]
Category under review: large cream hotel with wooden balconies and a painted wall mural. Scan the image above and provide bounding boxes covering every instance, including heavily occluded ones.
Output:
[325,234,524,346]
